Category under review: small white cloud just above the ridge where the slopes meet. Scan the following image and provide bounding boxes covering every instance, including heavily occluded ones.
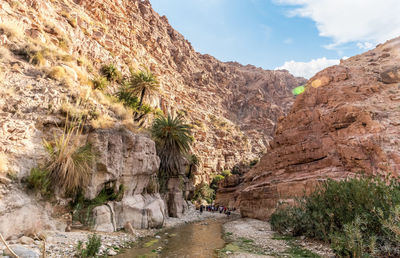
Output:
[275,57,340,79]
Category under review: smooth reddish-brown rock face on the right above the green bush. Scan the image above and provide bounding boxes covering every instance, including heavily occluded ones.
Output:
[240,38,400,219]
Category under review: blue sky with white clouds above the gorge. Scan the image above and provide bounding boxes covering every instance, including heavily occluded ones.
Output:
[150,0,400,77]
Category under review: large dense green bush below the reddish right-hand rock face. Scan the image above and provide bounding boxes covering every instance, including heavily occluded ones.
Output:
[270,177,400,257]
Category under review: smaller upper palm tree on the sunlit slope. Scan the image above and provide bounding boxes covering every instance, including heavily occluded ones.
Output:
[127,68,160,109]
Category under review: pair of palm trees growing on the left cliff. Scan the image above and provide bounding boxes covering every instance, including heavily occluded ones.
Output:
[119,68,199,191]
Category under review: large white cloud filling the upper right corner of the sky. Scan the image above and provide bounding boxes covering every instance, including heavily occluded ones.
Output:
[274,0,400,49]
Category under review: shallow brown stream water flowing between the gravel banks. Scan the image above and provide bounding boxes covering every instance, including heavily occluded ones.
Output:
[117,220,225,258]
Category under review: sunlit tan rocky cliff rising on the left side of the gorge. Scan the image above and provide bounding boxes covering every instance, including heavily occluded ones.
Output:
[0,0,305,236]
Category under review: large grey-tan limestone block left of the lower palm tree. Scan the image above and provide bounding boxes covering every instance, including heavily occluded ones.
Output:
[85,129,160,199]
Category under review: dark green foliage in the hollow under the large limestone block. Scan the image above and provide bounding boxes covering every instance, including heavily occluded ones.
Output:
[70,183,125,226]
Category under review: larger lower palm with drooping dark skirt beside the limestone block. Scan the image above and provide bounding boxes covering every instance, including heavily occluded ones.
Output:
[151,114,193,190]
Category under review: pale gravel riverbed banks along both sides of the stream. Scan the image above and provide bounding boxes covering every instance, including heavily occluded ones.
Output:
[0,210,334,257]
